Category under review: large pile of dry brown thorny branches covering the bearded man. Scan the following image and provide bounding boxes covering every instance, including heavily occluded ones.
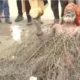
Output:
[0,34,80,80]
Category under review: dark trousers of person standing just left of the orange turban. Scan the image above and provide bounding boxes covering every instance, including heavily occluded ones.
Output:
[51,0,68,19]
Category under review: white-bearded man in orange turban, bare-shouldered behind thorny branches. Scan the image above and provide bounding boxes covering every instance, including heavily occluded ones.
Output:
[38,3,80,40]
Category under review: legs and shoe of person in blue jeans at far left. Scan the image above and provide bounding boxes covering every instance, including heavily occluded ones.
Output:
[0,0,12,24]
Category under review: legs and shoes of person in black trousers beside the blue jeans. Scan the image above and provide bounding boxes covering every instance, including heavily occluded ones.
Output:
[15,0,32,25]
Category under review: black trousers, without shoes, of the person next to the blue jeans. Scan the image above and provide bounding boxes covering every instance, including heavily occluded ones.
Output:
[17,0,31,19]
